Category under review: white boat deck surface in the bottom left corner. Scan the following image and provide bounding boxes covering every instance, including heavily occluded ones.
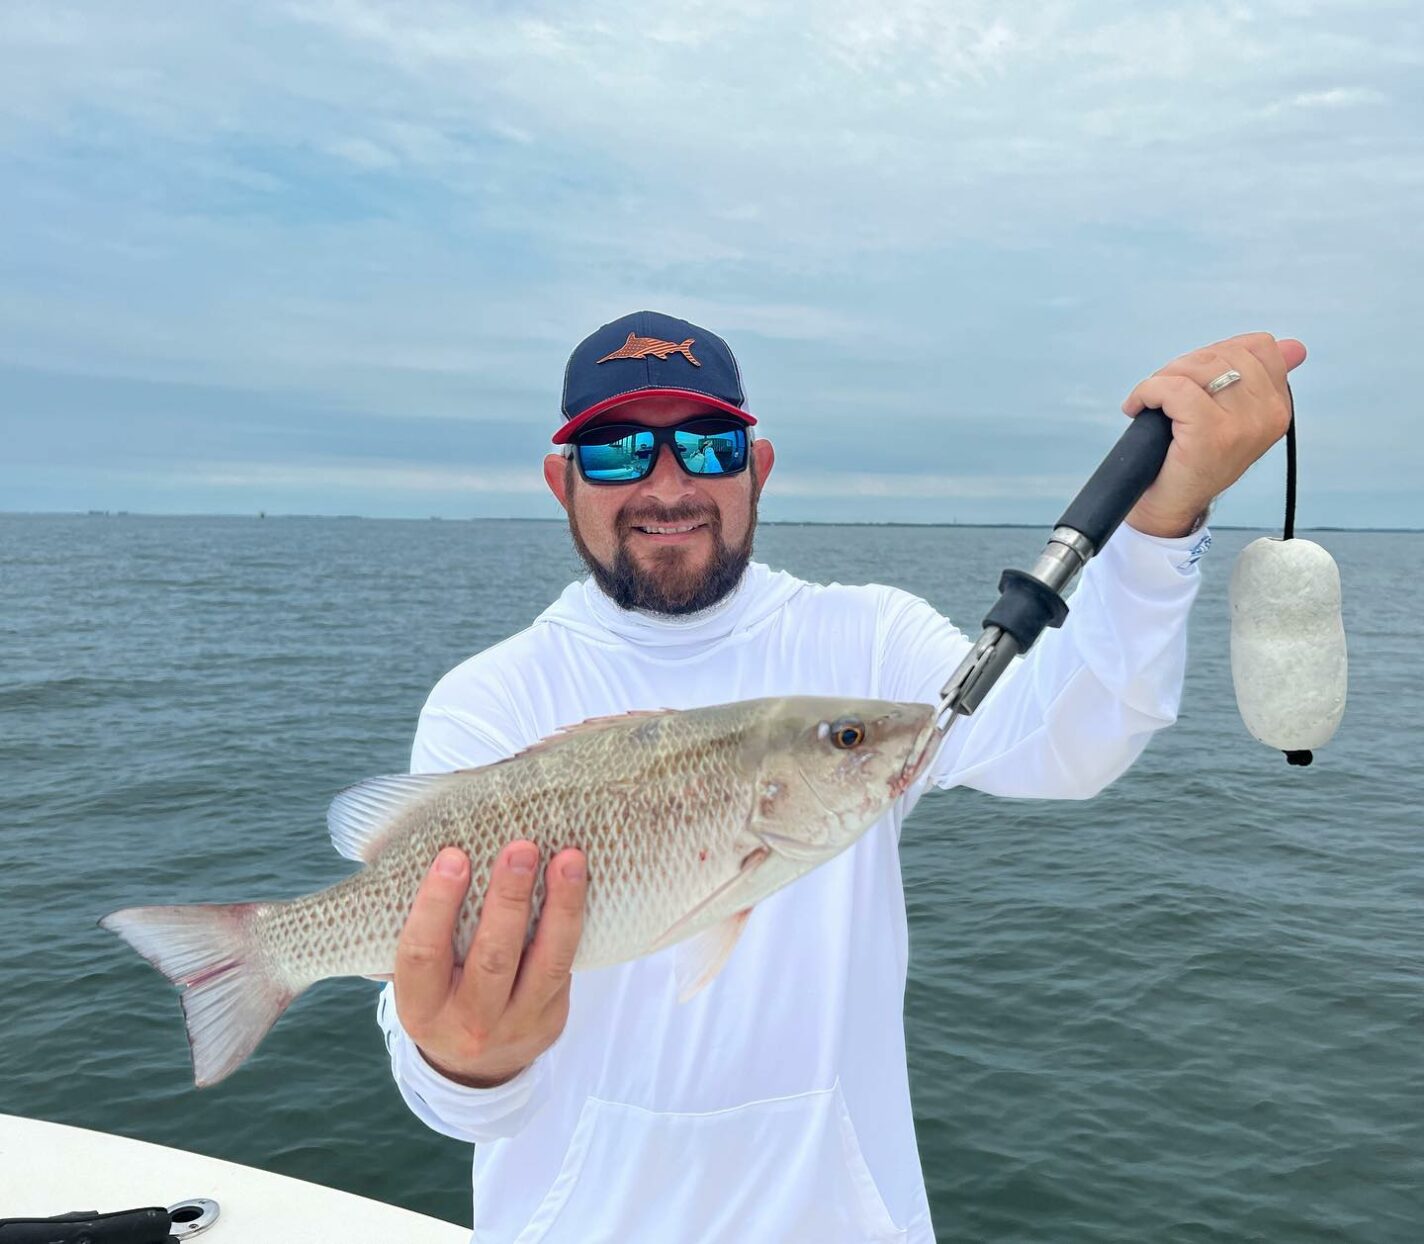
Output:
[0,1114,470,1244]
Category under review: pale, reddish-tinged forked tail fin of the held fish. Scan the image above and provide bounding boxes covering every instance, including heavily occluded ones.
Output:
[100,902,305,1089]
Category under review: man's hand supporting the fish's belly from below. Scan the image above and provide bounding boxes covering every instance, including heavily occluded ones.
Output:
[396,841,588,1089]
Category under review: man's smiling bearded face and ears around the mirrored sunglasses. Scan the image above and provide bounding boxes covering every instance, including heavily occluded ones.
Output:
[544,397,775,613]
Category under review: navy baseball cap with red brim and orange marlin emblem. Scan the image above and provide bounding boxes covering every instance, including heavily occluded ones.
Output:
[554,312,756,446]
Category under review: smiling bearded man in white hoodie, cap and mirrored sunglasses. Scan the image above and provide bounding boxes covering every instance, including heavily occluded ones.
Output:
[380,312,1304,1244]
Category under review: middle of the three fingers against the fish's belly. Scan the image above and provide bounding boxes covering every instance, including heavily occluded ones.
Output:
[457,840,538,1032]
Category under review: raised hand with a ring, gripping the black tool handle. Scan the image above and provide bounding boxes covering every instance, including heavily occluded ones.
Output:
[1122,333,1306,535]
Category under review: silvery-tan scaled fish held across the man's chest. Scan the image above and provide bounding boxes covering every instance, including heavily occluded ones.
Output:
[100,696,934,1087]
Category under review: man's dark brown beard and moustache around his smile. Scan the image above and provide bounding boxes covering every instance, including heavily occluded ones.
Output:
[568,463,760,615]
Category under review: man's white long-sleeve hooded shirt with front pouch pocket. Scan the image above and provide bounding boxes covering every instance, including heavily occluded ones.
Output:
[379,527,1209,1244]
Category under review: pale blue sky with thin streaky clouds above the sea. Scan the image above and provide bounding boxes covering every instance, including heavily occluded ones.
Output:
[0,0,1424,527]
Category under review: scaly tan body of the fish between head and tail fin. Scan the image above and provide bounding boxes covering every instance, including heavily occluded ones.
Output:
[256,697,752,985]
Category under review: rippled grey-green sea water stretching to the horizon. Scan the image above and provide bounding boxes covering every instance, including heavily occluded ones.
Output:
[0,515,1424,1244]
